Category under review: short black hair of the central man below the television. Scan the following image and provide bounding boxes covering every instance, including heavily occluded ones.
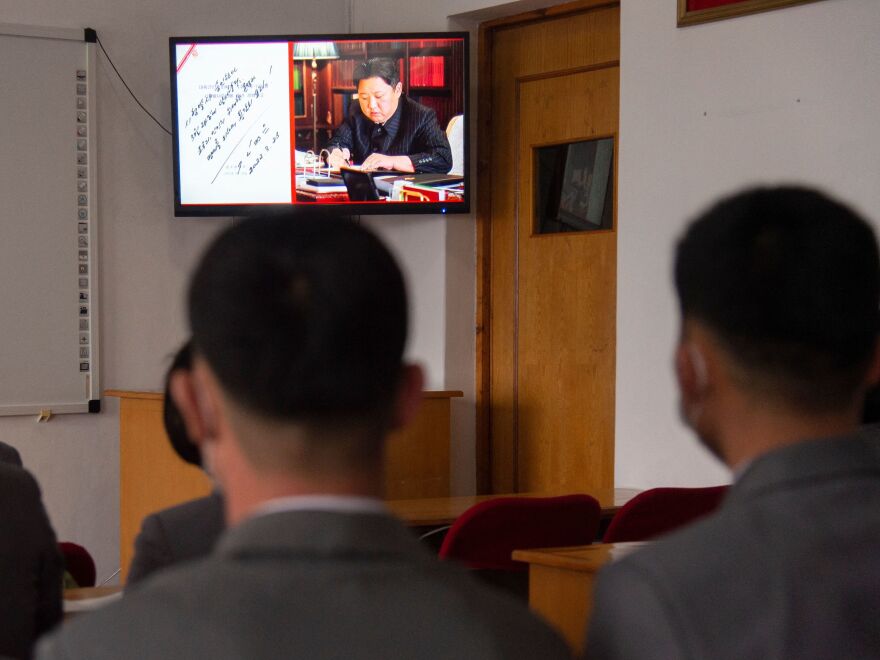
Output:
[189,212,407,423]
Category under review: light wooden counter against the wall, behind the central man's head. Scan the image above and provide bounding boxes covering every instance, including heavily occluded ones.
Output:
[105,390,462,582]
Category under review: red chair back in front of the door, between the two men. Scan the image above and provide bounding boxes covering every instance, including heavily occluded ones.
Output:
[439,495,601,571]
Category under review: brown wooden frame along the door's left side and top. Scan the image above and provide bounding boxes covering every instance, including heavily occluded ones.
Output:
[472,0,620,494]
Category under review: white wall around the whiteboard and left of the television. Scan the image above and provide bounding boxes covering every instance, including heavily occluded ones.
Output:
[0,0,348,581]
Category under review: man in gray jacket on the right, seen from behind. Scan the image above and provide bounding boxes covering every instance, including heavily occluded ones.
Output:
[586,187,880,660]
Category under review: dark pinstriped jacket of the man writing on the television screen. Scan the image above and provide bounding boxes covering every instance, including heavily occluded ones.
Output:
[327,96,452,174]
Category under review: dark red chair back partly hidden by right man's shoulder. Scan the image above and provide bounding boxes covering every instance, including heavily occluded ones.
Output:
[602,486,728,543]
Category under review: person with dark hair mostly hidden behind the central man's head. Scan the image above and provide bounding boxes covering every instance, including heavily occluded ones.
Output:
[125,341,226,590]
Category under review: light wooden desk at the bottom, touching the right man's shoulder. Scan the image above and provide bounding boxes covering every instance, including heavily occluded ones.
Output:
[513,543,645,655]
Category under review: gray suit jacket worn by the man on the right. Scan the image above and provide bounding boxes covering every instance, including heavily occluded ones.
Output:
[587,433,880,660]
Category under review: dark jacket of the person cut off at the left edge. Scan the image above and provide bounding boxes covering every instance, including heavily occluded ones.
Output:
[0,463,63,658]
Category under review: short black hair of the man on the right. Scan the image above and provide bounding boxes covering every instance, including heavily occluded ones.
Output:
[675,186,880,410]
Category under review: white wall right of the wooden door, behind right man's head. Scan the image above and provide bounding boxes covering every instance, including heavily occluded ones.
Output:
[616,0,880,487]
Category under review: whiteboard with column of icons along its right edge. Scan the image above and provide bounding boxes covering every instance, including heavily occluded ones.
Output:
[0,24,100,415]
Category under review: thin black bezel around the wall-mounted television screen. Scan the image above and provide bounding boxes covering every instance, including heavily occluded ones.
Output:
[168,31,472,218]
